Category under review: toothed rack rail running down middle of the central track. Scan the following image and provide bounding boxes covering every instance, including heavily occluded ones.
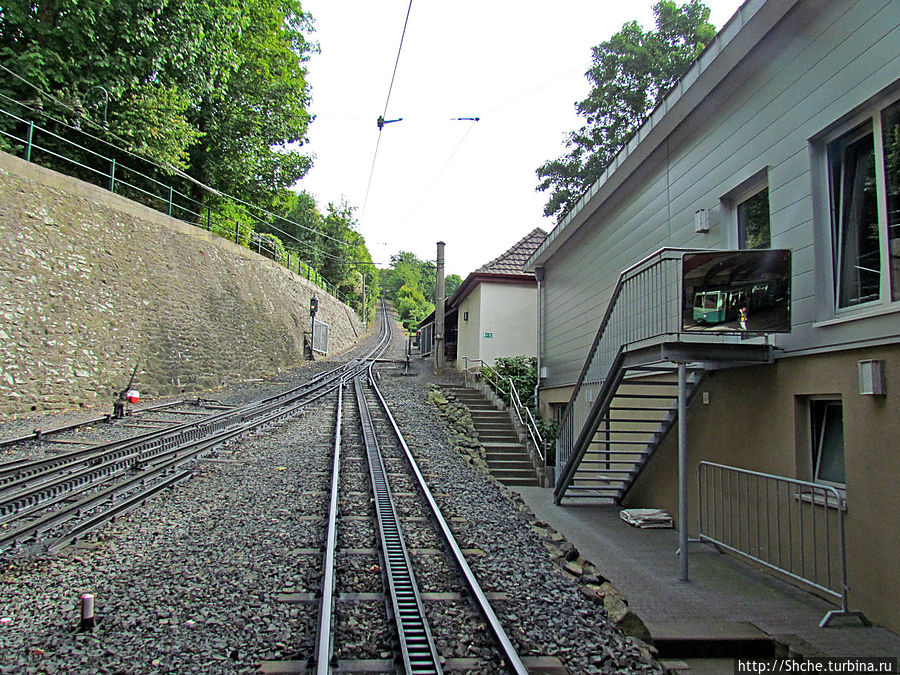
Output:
[353,375,443,673]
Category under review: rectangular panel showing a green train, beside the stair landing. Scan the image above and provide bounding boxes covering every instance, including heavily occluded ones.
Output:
[681,249,791,333]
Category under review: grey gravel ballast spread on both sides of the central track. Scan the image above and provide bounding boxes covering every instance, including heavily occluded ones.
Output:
[0,318,662,673]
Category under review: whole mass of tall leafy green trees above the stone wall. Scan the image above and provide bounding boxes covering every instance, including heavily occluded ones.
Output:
[0,0,317,212]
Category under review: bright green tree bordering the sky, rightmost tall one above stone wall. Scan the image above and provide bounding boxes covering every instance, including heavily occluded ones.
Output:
[183,0,316,211]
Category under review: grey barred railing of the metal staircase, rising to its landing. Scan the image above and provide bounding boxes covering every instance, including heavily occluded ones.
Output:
[556,247,707,485]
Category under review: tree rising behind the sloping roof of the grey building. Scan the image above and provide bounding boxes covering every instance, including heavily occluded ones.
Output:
[537,0,716,218]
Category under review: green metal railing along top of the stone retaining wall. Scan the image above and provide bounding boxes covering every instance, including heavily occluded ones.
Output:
[0,102,352,309]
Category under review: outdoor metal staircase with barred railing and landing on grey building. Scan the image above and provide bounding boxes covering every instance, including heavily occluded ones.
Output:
[554,249,772,504]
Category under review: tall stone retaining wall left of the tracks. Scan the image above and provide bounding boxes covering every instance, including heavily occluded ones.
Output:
[0,153,364,418]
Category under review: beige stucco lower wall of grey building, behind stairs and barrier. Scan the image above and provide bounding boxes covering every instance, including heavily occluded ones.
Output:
[624,344,900,631]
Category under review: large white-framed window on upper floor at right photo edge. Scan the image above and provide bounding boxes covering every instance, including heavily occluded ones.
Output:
[828,102,900,309]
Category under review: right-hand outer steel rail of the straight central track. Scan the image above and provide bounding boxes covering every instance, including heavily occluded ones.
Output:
[368,367,528,675]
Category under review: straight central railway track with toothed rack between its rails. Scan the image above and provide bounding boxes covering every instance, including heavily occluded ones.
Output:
[253,365,544,675]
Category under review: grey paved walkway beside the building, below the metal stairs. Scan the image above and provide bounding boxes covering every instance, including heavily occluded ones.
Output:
[513,487,900,672]
